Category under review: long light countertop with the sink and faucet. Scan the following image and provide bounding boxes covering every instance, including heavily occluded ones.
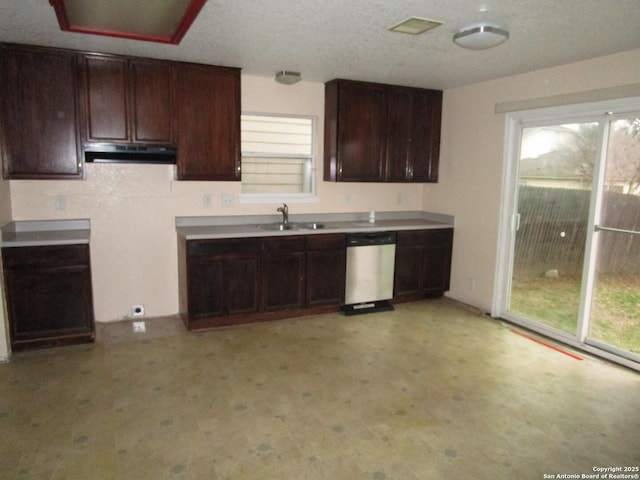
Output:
[176,211,454,240]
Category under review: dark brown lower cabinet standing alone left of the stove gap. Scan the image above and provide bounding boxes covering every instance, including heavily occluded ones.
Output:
[2,244,95,351]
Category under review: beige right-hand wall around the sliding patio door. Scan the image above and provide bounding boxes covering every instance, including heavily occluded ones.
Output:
[430,50,640,311]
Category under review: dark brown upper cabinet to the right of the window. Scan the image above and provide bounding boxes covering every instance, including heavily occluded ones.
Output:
[324,80,442,182]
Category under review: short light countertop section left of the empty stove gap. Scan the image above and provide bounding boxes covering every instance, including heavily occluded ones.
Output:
[0,219,91,248]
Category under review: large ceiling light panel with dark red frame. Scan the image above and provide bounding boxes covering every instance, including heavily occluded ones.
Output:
[49,0,207,44]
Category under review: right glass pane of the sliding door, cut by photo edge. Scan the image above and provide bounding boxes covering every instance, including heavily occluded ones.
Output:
[587,116,640,358]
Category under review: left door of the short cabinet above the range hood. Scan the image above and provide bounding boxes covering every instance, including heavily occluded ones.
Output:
[83,55,130,142]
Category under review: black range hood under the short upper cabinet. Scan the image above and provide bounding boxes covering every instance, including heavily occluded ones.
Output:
[84,143,176,165]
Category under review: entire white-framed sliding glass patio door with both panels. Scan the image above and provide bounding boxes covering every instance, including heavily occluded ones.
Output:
[492,99,640,369]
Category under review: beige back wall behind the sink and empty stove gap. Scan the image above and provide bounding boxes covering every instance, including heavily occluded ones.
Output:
[11,76,423,321]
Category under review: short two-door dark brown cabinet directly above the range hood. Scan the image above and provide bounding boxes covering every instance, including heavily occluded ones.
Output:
[82,54,175,145]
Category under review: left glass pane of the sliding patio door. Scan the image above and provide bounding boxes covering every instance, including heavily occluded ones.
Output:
[509,122,598,334]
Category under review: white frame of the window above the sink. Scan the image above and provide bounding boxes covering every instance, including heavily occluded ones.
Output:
[238,111,320,203]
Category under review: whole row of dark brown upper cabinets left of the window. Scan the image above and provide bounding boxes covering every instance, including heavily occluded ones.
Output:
[0,43,240,181]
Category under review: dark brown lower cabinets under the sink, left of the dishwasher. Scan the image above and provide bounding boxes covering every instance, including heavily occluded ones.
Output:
[178,233,346,330]
